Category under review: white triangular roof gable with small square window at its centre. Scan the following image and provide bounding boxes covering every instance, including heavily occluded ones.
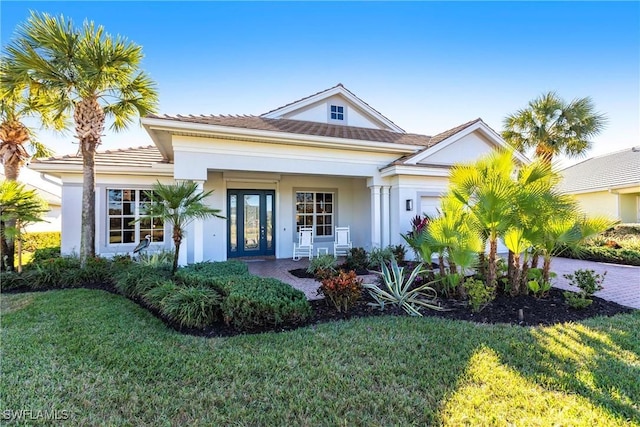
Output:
[260,83,404,133]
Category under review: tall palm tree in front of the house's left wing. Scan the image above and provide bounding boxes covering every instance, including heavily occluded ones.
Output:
[1,12,158,266]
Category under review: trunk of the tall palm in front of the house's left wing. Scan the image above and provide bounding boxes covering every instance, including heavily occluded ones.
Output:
[80,141,96,268]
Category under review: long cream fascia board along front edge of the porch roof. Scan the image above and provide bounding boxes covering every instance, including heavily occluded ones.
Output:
[143,118,424,154]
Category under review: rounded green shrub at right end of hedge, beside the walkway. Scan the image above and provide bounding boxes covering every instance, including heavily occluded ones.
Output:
[222,276,311,330]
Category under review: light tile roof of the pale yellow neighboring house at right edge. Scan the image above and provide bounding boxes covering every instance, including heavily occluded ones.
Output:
[558,146,640,193]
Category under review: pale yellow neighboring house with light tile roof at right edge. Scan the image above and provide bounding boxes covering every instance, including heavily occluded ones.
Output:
[559,146,640,223]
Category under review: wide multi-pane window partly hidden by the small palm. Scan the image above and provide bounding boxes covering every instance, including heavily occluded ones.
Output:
[107,189,164,245]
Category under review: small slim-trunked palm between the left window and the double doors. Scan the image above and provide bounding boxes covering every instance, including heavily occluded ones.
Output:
[138,181,224,273]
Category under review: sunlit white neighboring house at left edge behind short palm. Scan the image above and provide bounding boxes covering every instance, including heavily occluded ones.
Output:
[0,168,62,232]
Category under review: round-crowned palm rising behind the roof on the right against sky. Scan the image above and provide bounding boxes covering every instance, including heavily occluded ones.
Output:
[502,92,607,163]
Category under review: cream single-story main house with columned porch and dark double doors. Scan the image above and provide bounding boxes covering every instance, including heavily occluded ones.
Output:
[31,84,527,263]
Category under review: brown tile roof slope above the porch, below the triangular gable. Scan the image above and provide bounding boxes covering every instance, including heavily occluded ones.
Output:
[147,115,431,147]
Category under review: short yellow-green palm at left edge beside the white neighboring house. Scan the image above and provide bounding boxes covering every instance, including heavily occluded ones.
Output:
[0,180,47,270]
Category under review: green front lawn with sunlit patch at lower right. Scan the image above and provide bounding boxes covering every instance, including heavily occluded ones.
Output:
[0,289,640,426]
